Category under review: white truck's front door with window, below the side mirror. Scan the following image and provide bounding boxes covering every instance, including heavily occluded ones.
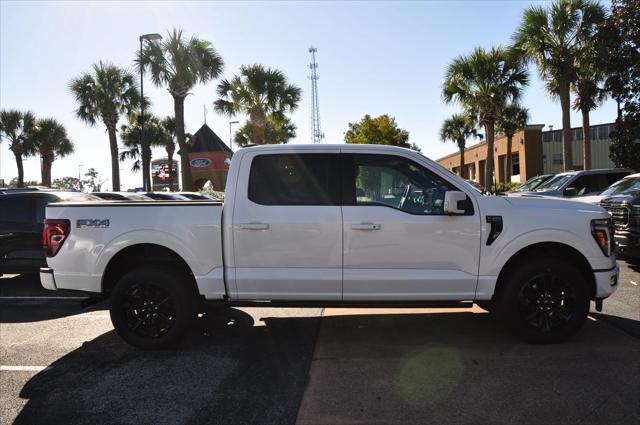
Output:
[342,153,480,301]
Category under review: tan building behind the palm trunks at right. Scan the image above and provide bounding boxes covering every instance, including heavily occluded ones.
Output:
[437,123,615,186]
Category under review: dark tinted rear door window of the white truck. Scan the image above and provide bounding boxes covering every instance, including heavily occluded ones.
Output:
[249,154,340,205]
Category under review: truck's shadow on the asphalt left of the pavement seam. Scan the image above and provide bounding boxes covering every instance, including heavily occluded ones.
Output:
[15,308,320,425]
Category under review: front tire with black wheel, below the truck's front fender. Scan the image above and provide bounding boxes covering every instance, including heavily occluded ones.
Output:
[497,257,590,344]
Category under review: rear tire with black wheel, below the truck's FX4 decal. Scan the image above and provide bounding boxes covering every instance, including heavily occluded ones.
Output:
[109,266,197,350]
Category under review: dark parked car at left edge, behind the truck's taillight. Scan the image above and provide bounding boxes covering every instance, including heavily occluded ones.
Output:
[0,190,100,274]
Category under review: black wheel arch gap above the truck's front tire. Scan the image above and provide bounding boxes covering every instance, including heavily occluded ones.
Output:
[494,242,596,299]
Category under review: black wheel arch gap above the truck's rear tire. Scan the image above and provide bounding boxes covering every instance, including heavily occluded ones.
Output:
[101,243,199,295]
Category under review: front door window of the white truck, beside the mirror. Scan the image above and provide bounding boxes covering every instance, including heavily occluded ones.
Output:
[345,155,457,215]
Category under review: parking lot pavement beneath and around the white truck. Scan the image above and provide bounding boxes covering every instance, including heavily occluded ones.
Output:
[0,261,640,425]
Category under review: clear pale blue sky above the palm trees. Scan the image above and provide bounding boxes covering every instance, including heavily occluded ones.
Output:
[0,0,616,189]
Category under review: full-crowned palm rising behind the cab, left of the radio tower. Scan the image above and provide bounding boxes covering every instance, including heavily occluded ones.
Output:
[214,64,302,145]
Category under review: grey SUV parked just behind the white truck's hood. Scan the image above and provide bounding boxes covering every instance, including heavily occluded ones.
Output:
[509,168,634,198]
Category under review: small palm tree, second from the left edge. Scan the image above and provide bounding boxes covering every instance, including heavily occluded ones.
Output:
[32,118,74,187]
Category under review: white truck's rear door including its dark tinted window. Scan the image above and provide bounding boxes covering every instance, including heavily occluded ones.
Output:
[228,149,343,300]
